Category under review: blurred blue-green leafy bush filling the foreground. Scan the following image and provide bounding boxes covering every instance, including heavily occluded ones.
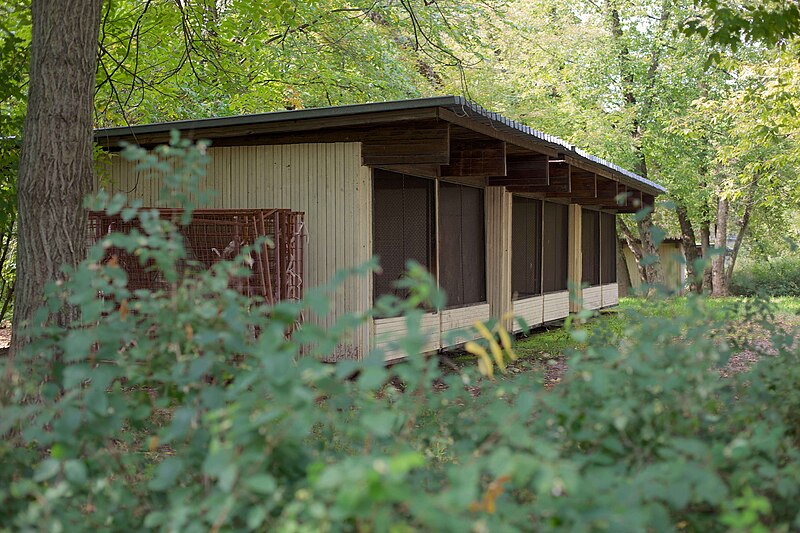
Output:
[0,138,800,532]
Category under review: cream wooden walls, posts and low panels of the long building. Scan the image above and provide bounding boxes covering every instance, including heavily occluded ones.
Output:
[104,142,628,359]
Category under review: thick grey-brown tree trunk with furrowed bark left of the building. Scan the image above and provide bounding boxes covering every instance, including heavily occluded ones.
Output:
[12,0,102,355]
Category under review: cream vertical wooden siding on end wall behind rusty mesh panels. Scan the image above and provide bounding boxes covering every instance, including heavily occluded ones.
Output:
[106,143,372,358]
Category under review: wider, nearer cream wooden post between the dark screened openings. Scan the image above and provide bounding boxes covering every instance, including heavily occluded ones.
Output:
[486,187,513,329]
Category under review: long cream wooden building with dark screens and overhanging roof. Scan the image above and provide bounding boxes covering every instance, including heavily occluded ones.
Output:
[95,96,664,359]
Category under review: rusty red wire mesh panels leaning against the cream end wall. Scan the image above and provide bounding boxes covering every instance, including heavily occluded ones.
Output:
[87,209,306,303]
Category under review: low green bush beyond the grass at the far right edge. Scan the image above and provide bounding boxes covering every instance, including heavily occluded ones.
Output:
[730,255,800,296]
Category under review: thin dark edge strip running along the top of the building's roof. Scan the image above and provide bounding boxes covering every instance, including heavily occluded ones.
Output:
[94,96,666,194]
